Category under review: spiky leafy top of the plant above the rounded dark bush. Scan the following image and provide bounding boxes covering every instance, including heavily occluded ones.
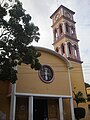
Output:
[73,91,86,107]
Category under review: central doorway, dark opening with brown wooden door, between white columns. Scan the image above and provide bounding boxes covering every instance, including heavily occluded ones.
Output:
[33,98,59,120]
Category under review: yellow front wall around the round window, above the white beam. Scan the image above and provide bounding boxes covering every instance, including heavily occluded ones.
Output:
[16,48,70,95]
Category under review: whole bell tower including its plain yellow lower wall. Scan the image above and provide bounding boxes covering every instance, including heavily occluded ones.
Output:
[50,5,90,120]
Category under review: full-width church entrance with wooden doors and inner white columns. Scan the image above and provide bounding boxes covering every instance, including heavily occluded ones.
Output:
[14,96,73,120]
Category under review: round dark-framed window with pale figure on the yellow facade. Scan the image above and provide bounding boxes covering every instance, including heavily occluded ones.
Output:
[39,65,54,83]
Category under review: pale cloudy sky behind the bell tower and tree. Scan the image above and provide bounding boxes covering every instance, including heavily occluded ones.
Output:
[21,0,90,84]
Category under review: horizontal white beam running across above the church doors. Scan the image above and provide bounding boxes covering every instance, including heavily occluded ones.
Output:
[15,92,72,98]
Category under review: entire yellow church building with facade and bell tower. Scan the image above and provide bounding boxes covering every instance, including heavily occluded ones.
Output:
[0,5,90,120]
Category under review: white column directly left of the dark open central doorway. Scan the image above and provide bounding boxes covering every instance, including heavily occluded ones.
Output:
[28,96,33,120]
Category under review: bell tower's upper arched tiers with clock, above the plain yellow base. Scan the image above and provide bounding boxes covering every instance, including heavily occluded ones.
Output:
[50,5,81,62]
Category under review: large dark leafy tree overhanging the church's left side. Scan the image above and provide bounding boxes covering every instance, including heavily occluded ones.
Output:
[0,0,41,83]
